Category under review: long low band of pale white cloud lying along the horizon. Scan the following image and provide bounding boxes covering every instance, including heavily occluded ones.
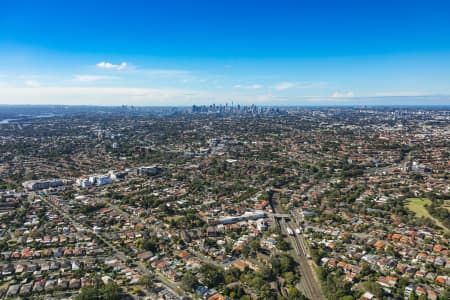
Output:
[0,86,450,106]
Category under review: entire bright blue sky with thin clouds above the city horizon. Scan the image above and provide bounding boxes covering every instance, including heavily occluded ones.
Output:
[0,0,450,105]
